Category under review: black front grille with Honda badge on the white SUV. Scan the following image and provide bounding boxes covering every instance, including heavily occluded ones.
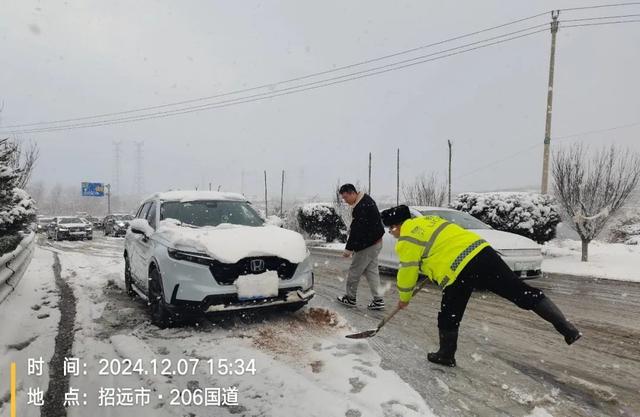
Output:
[209,256,298,285]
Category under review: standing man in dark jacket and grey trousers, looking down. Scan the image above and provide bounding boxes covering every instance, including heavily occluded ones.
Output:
[338,184,384,310]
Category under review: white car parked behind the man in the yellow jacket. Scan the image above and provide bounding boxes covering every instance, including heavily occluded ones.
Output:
[379,207,542,278]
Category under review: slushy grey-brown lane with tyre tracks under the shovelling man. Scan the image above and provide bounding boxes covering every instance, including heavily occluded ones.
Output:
[315,249,640,417]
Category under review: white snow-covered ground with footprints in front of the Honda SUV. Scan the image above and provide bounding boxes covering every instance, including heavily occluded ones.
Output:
[0,239,434,417]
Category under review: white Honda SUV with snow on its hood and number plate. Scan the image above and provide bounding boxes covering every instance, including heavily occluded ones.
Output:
[124,191,315,326]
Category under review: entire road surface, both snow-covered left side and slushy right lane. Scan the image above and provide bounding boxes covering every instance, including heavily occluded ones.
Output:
[0,237,640,417]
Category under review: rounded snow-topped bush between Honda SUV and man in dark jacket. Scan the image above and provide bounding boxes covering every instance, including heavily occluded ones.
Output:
[296,203,347,242]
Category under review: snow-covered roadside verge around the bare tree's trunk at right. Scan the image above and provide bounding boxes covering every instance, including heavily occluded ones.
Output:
[542,239,640,282]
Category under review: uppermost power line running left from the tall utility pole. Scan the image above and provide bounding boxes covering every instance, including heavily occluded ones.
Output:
[4,11,549,129]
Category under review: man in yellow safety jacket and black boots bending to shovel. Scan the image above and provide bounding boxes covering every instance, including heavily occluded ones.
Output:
[381,205,582,366]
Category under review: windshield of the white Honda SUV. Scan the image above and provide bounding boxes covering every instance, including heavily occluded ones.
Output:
[160,201,264,226]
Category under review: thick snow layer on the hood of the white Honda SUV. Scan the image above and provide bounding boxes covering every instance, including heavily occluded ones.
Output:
[154,220,307,263]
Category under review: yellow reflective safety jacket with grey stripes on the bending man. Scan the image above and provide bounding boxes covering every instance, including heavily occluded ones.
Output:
[395,216,489,302]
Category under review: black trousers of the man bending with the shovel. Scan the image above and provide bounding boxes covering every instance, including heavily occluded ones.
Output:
[438,247,544,330]
